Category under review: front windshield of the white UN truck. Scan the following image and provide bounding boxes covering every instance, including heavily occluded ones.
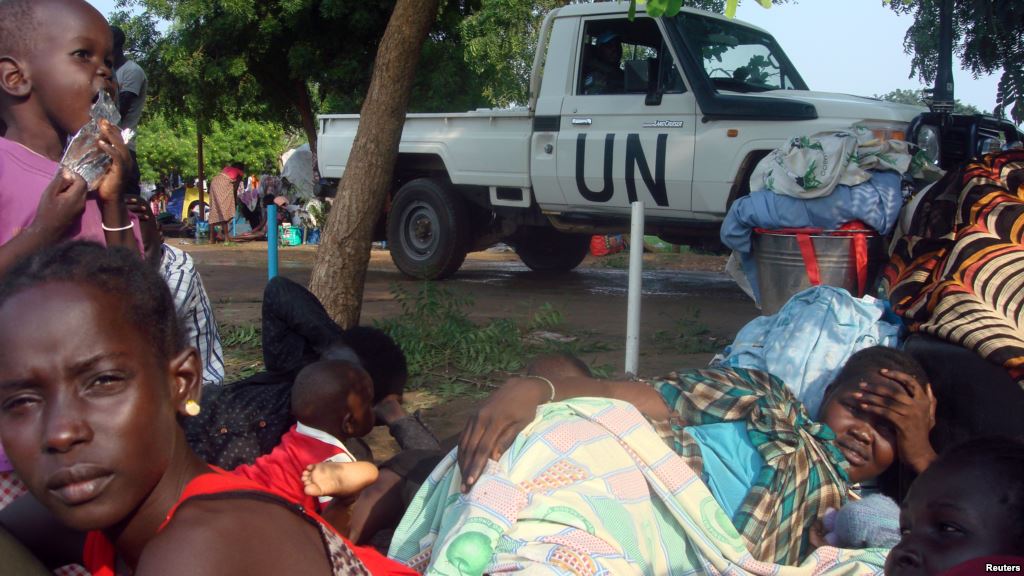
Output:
[674,12,807,92]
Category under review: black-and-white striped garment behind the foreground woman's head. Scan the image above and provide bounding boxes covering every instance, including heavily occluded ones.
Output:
[160,244,224,385]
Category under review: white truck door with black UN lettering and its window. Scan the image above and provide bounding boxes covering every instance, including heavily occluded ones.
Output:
[556,14,696,214]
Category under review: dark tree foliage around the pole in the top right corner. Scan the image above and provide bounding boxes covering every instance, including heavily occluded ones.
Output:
[888,0,1024,123]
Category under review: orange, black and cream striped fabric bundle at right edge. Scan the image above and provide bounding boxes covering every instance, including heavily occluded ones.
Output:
[884,151,1024,387]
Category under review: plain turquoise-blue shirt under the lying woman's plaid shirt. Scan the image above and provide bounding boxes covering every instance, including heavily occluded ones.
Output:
[685,421,765,520]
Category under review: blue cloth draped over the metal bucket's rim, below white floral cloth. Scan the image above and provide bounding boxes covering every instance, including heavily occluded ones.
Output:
[720,171,903,302]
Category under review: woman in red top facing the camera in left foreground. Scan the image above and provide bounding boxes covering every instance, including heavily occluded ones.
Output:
[0,242,412,576]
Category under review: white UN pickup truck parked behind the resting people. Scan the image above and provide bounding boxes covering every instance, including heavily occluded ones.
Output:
[317,2,925,279]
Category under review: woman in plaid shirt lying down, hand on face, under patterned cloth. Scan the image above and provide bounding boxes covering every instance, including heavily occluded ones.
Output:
[389,347,935,574]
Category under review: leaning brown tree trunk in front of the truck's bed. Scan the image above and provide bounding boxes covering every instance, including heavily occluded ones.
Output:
[309,0,438,328]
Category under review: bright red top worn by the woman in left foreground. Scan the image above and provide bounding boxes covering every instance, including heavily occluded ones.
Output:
[82,466,418,576]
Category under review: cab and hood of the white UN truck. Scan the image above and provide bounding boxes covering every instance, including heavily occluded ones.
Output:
[530,5,924,233]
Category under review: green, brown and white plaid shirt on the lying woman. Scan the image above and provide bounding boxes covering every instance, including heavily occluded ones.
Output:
[649,368,849,565]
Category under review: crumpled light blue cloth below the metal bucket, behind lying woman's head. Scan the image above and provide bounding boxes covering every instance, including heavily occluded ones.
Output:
[722,286,901,417]
